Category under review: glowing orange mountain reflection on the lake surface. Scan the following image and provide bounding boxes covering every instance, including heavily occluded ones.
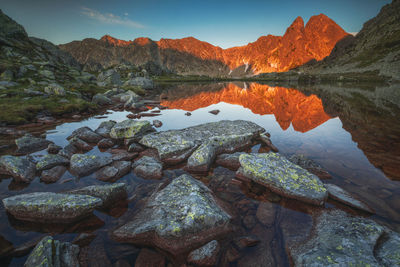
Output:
[161,83,331,133]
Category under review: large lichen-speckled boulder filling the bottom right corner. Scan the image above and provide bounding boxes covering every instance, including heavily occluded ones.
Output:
[288,210,400,267]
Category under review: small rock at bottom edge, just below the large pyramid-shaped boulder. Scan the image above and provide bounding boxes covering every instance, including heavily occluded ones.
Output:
[188,240,220,266]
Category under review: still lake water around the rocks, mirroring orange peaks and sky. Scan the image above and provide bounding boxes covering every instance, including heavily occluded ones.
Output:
[0,83,400,266]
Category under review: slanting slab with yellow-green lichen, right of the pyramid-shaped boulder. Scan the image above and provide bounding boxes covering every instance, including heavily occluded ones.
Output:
[237,152,328,205]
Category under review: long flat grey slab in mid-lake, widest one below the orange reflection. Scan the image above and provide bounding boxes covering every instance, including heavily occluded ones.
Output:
[139,120,265,161]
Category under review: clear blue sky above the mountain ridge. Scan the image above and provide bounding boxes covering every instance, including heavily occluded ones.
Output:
[0,0,391,48]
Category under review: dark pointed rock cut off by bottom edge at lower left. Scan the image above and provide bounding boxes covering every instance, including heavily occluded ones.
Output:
[24,236,79,267]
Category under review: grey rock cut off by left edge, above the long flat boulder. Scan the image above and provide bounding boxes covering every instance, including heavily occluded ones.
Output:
[0,155,36,183]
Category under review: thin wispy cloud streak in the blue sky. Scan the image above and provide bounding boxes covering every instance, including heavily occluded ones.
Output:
[80,7,145,28]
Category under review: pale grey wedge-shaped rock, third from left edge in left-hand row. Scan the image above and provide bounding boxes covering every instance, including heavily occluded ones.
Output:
[70,154,112,176]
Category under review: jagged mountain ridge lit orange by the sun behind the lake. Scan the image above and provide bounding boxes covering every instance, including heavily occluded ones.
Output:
[59,14,348,77]
